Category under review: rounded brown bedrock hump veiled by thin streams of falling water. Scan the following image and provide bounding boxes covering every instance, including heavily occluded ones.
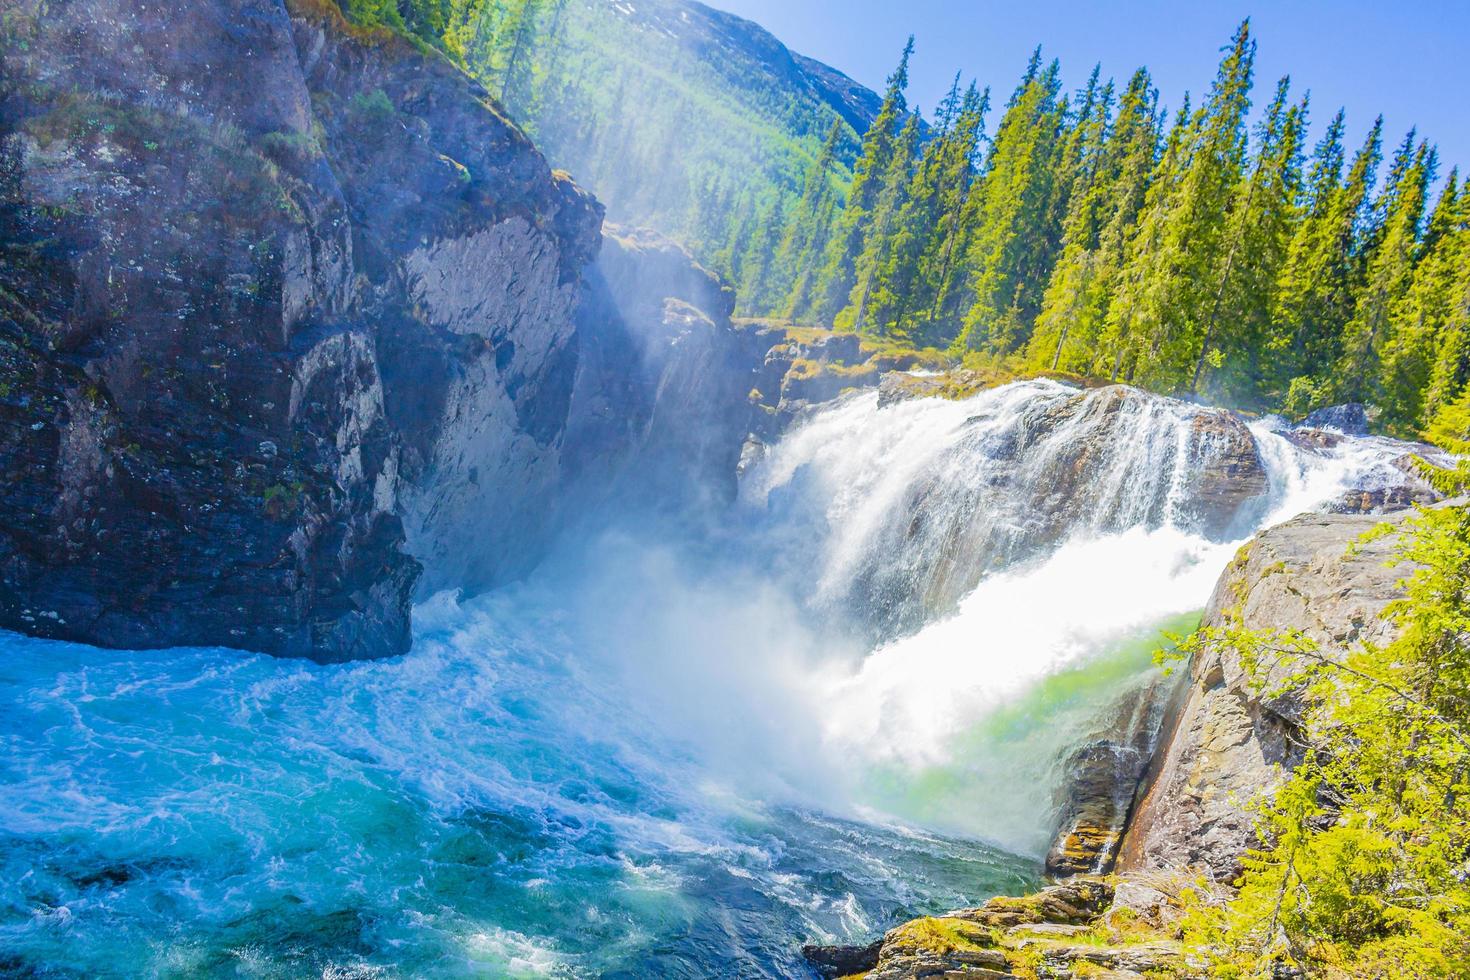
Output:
[847,385,1269,636]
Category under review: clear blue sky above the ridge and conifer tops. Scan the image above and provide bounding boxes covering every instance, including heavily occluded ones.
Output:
[707,0,1470,179]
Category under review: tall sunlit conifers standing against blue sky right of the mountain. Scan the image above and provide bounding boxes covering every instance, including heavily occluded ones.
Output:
[745,24,1470,428]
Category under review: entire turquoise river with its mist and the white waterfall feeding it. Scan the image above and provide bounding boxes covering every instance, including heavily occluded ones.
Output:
[0,382,1428,977]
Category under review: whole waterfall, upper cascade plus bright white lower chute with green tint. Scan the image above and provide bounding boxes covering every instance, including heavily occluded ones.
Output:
[742,381,1414,852]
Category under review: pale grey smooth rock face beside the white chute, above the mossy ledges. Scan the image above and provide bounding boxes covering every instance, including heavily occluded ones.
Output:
[1117,514,1410,882]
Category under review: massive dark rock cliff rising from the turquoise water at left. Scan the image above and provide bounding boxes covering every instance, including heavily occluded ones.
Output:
[0,0,744,660]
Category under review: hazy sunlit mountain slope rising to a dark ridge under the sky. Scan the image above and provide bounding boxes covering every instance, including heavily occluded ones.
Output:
[482,0,879,260]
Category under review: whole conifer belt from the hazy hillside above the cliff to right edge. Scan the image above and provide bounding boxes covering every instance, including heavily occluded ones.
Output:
[359,0,1470,432]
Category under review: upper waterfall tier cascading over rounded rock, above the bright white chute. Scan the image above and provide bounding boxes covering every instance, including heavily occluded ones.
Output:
[742,381,1410,636]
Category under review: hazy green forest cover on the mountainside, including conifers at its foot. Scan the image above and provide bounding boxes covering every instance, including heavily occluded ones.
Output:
[429,0,858,295]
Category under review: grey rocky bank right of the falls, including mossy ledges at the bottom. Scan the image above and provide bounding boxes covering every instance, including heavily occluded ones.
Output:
[804,514,1405,980]
